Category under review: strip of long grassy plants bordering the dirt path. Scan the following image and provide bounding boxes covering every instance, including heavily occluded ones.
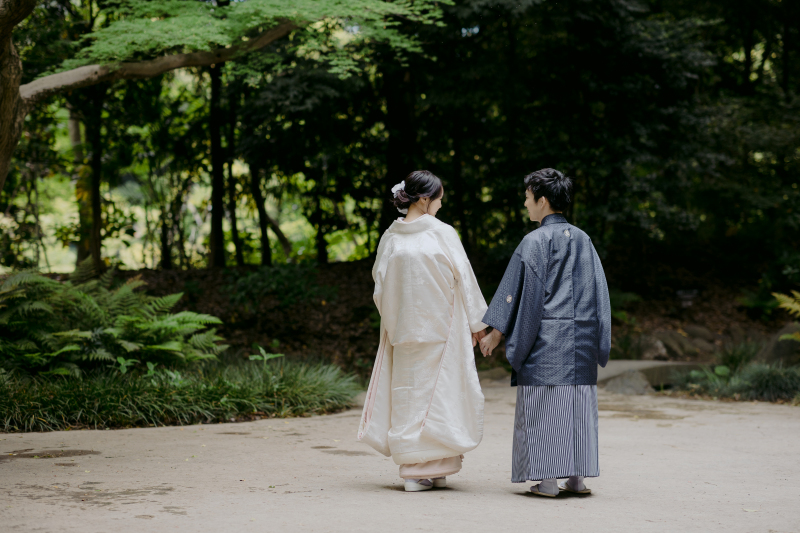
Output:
[0,362,360,432]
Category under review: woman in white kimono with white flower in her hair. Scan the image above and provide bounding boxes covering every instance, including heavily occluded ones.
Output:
[358,170,487,491]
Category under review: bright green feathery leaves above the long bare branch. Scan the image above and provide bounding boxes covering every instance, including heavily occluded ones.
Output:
[55,0,450,73]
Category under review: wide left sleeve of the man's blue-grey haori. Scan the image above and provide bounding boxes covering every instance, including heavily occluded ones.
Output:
[483,250,545,372]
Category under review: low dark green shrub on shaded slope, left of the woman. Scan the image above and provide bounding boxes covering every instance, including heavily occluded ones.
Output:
[228,264,337,312]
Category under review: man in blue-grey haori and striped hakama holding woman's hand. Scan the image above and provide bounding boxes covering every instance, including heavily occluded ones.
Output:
[481,168,611,497]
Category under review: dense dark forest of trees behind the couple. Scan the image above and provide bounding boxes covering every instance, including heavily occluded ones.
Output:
[0,0,800,368]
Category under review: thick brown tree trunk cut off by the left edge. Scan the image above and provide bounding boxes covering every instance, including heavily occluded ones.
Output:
[0,31,27,190]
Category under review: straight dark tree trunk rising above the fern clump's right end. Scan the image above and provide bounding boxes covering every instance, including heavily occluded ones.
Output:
[208,65,225,268]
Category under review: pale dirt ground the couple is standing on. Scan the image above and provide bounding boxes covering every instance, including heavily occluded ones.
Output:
[0,382,800,533]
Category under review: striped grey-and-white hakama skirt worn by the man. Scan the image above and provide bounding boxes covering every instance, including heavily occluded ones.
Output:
[511,385,600,483]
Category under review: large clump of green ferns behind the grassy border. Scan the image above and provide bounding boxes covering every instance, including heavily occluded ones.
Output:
[0,261,226,375]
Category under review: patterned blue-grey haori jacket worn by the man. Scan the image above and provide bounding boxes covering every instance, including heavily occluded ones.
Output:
[483,214,611,386]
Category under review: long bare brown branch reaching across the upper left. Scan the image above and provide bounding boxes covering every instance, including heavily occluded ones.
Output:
[18,20,297,105]
